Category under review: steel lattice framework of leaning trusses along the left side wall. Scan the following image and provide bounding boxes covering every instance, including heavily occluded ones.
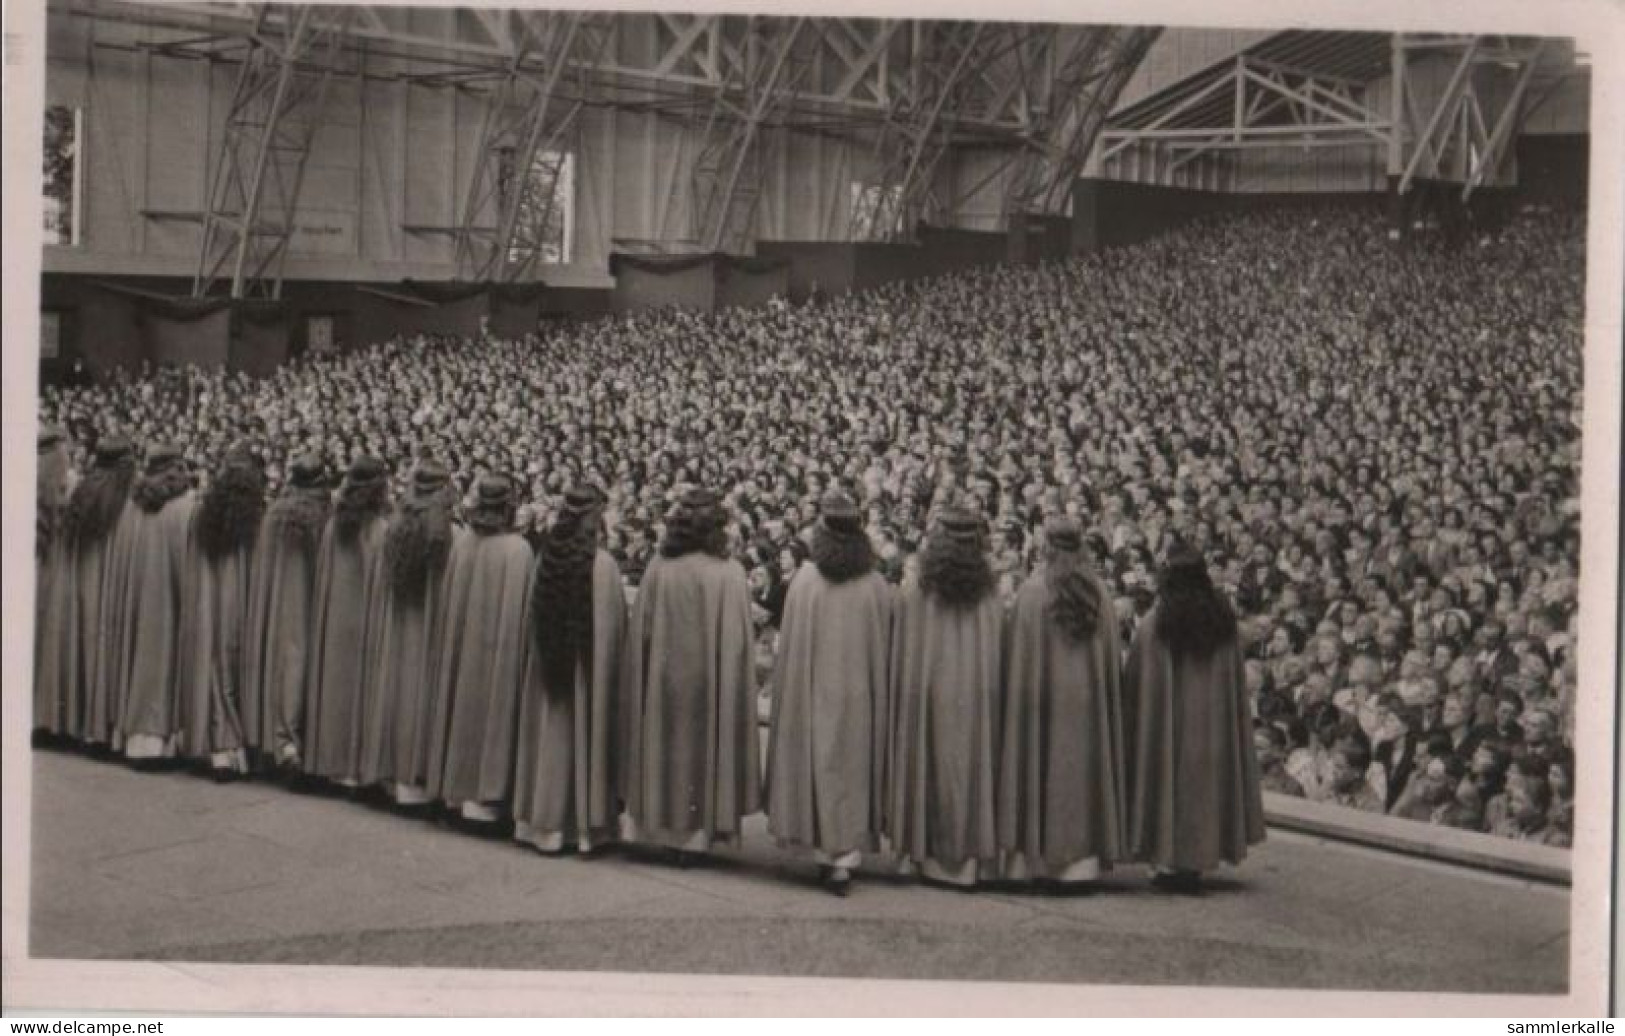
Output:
[69,0,1202,266]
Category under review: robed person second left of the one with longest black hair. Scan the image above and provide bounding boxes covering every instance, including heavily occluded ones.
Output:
[361,460,468,807]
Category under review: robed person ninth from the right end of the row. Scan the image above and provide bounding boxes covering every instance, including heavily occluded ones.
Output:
[301,456,390,788]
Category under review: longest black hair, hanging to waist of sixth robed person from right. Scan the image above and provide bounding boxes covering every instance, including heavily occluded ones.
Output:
[530,502,603,695]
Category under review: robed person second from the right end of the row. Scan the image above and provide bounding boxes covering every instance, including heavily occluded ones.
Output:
[999,518,1125,882]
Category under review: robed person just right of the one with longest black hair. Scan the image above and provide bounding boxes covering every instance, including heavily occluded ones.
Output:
[621,489,761,864]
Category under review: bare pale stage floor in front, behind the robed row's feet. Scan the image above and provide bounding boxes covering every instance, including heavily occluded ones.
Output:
[29,750,1570,992]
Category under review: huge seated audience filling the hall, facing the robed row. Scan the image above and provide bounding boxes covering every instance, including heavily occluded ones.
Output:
[41,206,1584,844]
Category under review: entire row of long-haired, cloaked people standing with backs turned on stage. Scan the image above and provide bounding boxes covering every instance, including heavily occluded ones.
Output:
[36,437,1264,893]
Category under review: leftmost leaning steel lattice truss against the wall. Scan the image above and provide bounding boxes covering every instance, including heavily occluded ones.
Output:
[192,6,351,299]
